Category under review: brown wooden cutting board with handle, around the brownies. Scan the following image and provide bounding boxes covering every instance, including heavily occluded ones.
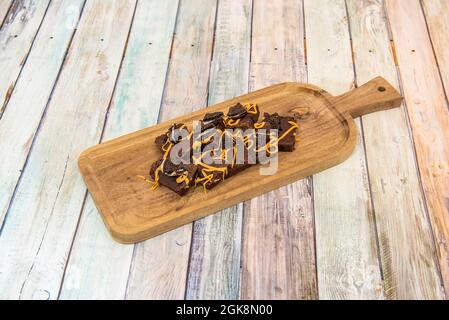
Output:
[79,78,402,243]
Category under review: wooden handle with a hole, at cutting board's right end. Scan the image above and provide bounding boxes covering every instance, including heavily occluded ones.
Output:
[335,77,402,118]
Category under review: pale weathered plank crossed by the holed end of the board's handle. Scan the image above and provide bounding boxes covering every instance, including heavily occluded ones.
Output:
[347,0,441,299]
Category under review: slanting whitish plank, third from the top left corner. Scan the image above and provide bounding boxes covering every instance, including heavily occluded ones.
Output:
[0,0,84,230]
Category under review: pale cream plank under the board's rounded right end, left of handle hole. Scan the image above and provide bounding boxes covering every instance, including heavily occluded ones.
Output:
[304,0,383,299]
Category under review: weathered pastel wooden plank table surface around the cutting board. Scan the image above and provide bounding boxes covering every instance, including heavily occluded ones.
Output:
[0,0,449,299]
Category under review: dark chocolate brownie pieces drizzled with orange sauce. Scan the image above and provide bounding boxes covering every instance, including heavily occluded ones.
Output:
[150,103,298,196]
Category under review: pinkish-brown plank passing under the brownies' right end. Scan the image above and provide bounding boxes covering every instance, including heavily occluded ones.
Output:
[241,0,317,299]
